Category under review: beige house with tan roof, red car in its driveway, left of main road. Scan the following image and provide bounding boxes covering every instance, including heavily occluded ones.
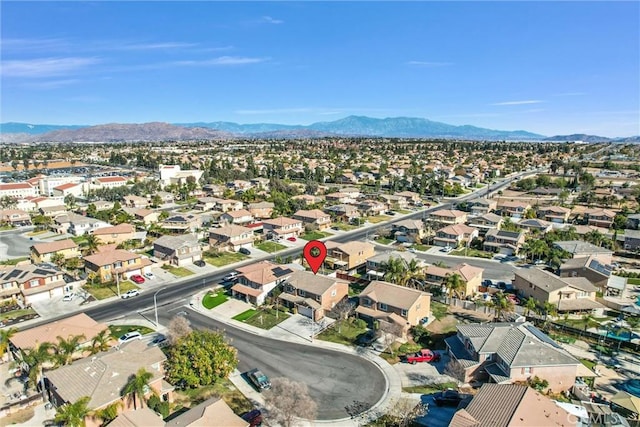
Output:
[84,249,151,283]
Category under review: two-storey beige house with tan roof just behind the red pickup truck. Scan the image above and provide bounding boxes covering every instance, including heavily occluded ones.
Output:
[356,280,431,335]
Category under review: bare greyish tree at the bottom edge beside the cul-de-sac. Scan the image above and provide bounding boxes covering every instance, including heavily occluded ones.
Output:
[264,378,317,427]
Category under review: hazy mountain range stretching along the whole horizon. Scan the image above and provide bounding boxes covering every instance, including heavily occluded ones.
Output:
[0,116,640,142]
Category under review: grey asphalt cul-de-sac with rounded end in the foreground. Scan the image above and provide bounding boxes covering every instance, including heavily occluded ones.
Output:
[144,303,386,420]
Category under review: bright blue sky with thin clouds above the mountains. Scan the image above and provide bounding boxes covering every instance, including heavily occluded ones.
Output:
[0,1,640,136]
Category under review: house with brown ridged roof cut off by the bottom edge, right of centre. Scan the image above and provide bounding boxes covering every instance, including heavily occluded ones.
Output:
[449,384,577,427]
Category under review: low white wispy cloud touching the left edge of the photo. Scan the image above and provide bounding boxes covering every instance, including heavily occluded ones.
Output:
[0,57,100,78]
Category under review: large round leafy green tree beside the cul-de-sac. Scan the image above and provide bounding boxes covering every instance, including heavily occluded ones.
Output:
[165,330,238,388]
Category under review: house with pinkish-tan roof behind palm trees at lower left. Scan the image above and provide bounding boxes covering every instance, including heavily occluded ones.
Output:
[9,313,109,360]
